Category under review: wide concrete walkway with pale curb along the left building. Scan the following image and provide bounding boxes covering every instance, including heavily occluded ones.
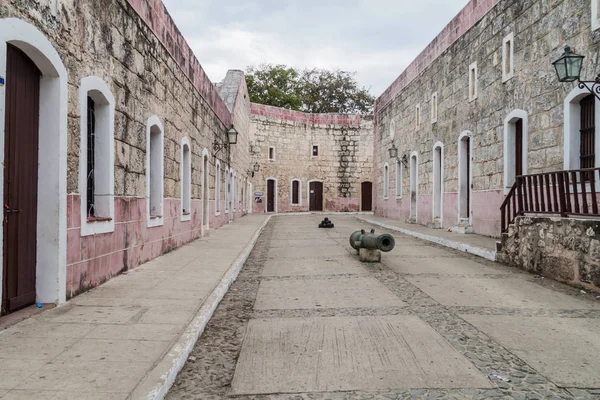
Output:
[0,214,268,400]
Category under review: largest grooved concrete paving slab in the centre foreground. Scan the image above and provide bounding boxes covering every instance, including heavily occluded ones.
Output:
[232,316,491,395]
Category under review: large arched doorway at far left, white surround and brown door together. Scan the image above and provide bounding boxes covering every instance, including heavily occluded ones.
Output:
[0,18,68,313]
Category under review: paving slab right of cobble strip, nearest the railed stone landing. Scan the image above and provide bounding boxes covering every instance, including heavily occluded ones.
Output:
[405,276,594,310]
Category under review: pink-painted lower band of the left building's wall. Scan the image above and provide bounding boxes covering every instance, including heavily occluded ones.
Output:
[67,194,245,298]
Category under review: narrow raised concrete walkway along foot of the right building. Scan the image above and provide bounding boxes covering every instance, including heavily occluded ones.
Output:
[356,215,500,261]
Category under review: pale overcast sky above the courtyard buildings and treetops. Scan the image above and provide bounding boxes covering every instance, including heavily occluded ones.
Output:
[163,0,468,95]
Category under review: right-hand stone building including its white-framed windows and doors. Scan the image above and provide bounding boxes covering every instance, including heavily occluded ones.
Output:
[374,0,600,237]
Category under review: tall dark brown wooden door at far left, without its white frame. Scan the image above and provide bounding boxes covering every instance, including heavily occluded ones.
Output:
[2,45,41,314]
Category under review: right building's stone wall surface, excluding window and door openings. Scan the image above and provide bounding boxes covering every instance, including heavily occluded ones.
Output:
[374,0,600,236]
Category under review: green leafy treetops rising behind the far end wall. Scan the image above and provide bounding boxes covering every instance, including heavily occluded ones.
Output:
[246,64,375,115]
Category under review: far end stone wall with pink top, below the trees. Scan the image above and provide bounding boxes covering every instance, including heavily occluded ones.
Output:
[250,104,373,212]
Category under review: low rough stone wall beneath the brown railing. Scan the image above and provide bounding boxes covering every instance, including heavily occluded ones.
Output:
[498,217,600,291]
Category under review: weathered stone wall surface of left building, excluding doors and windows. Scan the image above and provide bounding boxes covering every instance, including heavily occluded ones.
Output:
[0,0,250,297]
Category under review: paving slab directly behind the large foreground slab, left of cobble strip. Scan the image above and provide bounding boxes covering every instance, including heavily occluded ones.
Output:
[254,277,406,310]
